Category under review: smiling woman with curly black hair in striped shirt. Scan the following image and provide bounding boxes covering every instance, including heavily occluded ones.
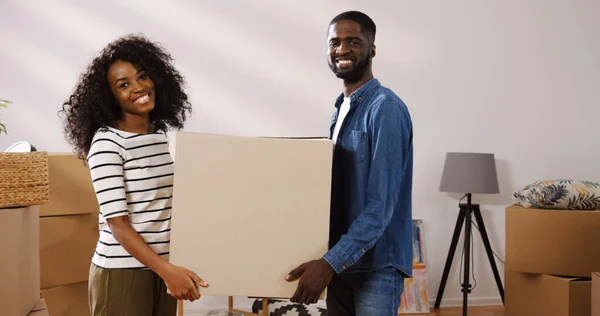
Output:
[61,36,208,316]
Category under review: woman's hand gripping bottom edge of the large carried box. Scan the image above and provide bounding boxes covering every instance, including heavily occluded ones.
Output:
[159,263,208,302]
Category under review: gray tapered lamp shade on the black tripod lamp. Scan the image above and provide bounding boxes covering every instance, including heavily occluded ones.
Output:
[440,152,500,194]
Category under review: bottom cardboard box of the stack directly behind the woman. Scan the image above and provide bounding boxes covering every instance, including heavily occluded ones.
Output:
[42,281,90,316]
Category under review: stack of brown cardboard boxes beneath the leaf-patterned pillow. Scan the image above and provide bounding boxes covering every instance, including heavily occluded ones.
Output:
[505,205,600,316]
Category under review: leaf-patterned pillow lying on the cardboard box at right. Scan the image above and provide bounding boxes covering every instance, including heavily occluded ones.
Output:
[513,180,600,210]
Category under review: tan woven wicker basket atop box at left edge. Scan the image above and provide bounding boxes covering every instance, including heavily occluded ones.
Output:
[0,152,50,208]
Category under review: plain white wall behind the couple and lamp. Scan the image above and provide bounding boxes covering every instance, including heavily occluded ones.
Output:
[0,0,600,307]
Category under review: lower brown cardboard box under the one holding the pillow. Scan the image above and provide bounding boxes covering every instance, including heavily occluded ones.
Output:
[504,271,591,316]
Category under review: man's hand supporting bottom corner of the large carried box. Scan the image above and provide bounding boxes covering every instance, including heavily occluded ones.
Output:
[285,258,334,304]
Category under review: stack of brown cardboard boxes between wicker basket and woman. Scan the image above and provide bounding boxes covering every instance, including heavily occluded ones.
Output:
[40,154,98,316]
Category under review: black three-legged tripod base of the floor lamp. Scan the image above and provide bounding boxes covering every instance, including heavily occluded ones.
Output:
[434,200,504,316]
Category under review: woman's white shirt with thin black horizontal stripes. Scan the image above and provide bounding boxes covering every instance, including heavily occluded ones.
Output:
[87,127,174,268]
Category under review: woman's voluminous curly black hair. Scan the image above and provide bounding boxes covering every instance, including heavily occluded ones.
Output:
[59,34,192,159]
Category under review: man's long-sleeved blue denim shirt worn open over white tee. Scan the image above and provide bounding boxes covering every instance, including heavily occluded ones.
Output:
[324,78,413,276]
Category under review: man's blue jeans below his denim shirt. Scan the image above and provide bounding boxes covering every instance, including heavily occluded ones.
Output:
[327,267,404,316]
